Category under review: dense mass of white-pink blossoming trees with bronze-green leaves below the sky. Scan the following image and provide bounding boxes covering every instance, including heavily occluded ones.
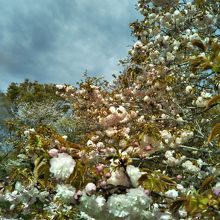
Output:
[0,0,220,220]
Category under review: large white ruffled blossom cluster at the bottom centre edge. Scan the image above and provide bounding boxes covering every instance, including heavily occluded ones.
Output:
[81,188,153,219]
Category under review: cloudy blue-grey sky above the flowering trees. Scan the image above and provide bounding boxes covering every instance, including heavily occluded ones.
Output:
[0,0,141,90]
